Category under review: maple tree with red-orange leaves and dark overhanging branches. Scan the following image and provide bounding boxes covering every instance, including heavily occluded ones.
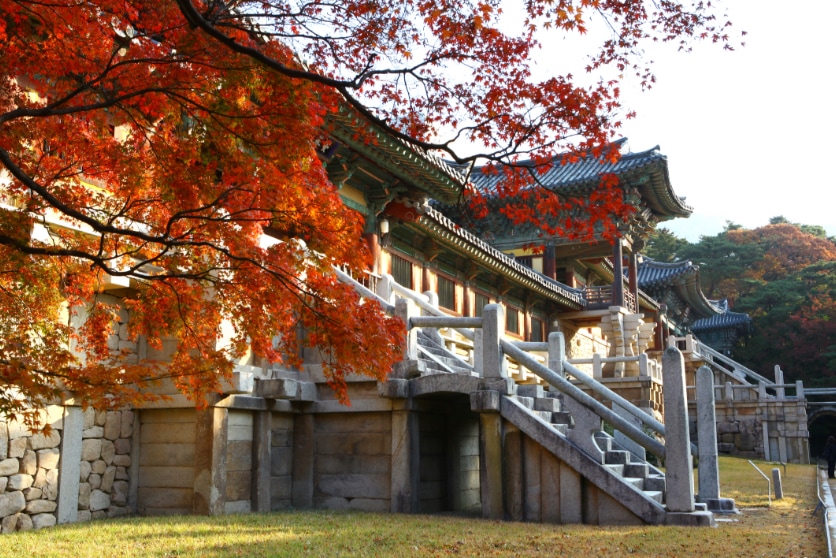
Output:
[0,0,731,422]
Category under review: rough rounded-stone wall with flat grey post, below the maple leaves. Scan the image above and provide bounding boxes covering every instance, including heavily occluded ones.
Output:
[0,406,134,533]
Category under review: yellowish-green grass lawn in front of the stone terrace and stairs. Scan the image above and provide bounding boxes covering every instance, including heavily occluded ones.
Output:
[0,458,826,558]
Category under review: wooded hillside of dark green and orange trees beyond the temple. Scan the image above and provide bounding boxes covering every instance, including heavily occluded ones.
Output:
[681,221,836,383]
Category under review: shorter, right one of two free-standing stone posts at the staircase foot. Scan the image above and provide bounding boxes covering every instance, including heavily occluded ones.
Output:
[696,366,720,502]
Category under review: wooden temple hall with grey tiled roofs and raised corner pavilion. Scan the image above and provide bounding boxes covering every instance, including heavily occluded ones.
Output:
[325,119,723,392]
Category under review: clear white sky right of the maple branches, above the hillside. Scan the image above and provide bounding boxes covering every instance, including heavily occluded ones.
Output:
[540,0,836,242]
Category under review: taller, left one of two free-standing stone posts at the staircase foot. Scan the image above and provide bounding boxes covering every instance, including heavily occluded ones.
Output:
[662,347,694,513]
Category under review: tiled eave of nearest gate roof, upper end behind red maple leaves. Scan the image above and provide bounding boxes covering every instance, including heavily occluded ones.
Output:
[329,108,466,203]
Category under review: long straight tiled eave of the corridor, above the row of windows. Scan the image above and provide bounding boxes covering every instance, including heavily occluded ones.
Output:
[416,209,586,310]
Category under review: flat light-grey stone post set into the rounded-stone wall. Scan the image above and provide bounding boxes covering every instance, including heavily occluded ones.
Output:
[55,406,82,523]
